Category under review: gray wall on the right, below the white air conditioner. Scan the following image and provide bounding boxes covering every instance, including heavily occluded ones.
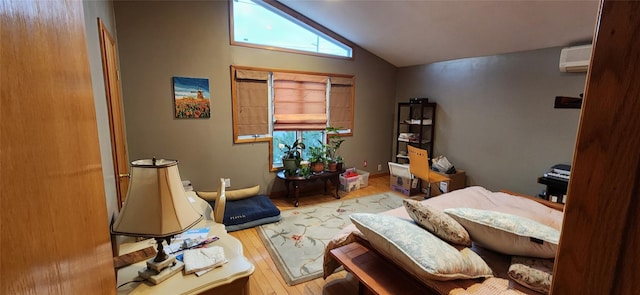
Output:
[396,48,586,195]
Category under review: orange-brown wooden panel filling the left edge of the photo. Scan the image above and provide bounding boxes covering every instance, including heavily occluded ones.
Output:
[0,0,115,294]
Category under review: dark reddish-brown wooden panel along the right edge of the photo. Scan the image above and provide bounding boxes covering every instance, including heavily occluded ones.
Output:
[552,0,640,294]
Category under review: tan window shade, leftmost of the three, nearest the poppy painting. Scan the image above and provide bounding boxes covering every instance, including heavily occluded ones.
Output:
[233,69,269,138]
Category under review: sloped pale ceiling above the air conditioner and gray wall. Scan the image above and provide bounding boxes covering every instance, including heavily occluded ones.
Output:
[278,0,598,67]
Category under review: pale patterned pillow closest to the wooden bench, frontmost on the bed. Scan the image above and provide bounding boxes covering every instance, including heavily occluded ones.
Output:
[350,213,492,285]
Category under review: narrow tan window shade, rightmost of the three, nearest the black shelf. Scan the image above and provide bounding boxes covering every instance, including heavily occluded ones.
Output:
[329,77,354,130]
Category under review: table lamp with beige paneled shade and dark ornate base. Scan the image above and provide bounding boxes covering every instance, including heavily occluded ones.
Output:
[111,158,203,284]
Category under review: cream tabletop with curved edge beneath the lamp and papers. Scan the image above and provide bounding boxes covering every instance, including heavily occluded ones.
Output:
[117,220,255,295]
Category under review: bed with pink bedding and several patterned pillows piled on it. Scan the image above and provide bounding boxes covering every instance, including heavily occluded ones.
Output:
[323,186,563,295]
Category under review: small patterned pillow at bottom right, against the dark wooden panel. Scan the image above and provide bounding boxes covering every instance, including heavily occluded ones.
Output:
[509,256,553,294]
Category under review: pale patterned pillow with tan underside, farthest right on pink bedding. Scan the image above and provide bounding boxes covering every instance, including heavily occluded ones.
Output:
[444,208,560,258]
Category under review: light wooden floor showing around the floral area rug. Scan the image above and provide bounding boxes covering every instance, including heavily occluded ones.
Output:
[230,175,416,295]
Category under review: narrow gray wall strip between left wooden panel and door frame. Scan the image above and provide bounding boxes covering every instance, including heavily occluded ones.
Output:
[82,1,118,222]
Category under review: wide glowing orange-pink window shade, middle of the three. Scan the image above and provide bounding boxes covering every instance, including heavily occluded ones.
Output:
[273,72,328,130]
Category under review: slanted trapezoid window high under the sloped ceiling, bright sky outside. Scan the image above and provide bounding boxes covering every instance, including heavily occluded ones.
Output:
[230,0,353,58]
